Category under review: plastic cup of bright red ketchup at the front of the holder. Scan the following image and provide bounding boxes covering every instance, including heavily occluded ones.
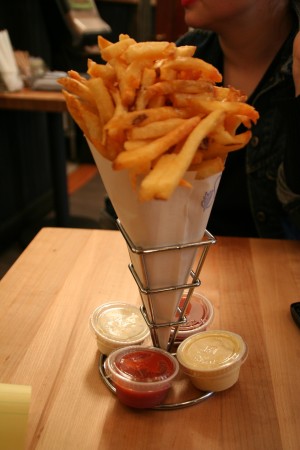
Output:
[105,346,179,409]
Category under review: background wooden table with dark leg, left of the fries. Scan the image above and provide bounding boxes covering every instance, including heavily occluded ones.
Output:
[0,89,70,226]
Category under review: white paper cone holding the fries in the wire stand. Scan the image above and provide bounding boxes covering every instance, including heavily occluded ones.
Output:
[89,143,221,349]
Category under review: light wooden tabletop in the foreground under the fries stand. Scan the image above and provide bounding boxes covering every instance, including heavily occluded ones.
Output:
[0,228,300,450]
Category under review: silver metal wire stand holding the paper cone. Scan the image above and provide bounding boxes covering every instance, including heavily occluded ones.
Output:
[99,219,216,410]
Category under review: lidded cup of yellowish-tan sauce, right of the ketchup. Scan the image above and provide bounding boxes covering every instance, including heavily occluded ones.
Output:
[177,330,248,392]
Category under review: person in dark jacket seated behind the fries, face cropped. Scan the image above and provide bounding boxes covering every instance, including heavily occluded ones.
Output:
[177,0,300,239]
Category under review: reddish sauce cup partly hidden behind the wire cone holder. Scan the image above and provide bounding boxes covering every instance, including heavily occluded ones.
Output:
[176,292,214,341]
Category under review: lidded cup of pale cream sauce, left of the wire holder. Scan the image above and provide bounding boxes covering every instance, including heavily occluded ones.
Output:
[90,302,150,355]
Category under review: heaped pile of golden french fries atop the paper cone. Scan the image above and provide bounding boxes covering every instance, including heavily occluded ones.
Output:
[58,35,259,201]
